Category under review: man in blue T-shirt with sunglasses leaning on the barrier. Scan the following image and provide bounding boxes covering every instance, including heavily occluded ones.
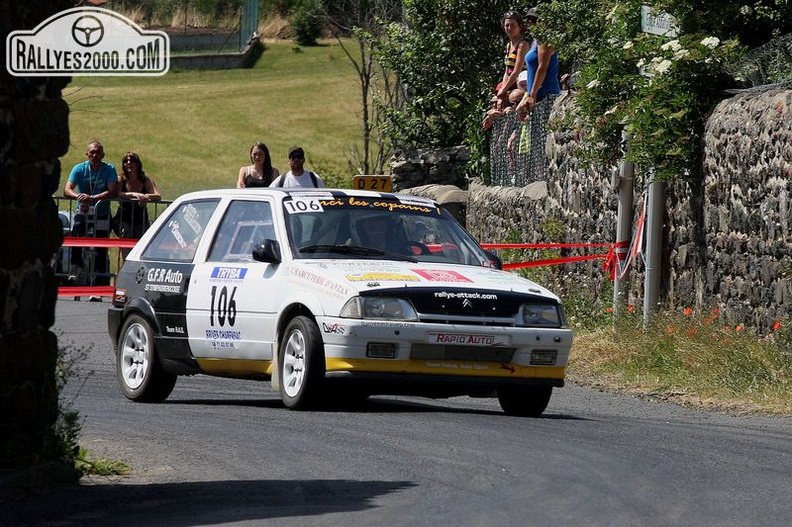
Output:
[63,141,118,302]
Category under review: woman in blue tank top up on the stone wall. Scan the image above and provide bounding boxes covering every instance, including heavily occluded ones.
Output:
[517,8,561,182]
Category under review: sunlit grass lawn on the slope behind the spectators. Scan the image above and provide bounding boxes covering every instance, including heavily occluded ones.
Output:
[61,41,362,199]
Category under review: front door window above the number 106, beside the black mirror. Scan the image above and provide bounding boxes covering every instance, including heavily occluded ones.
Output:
[209,200,275,262]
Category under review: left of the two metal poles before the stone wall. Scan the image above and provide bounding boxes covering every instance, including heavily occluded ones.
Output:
[613,132,635,318]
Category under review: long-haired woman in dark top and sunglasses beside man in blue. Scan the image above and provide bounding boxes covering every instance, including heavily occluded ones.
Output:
[115,152,162,258]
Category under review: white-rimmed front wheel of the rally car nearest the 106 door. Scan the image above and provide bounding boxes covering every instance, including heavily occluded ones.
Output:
[278,316,325,410]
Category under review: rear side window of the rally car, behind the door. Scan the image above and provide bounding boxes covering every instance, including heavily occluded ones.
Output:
[141,200,219,262]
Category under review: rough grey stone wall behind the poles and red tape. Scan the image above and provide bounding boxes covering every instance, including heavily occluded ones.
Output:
[467,91,792,331]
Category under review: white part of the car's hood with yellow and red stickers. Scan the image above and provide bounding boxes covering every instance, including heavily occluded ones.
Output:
[293,260,558,300]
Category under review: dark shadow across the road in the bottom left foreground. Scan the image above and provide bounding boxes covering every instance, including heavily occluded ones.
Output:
[0,480,415,527]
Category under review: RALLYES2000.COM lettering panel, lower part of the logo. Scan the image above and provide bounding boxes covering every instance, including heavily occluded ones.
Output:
[12,40,163,71]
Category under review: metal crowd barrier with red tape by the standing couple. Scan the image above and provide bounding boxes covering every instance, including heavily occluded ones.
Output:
[51,197,171,298]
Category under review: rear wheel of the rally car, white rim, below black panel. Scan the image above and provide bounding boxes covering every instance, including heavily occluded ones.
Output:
[116,315,176,403]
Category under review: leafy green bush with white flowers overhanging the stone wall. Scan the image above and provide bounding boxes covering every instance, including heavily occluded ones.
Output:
[537,0,792,180]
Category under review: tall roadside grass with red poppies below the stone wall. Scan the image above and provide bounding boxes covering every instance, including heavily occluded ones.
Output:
[569,309,792,414]
